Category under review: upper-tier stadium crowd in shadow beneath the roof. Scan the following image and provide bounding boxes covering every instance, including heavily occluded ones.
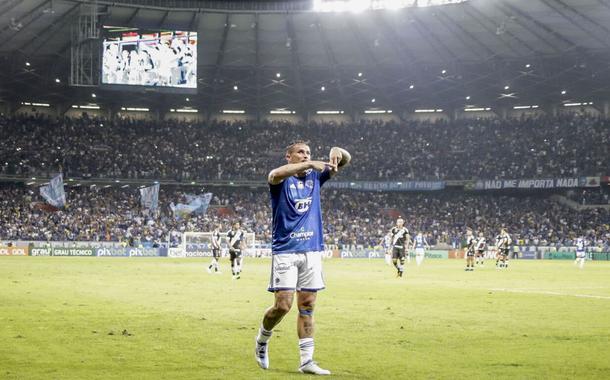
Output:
[0,114,610,181]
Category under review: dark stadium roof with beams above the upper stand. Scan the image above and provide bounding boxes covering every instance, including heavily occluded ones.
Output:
[0,0,610,112]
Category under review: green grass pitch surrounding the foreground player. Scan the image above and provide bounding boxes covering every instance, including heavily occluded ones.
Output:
[0,257,610,379]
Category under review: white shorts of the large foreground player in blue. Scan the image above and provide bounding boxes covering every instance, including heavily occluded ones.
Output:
[267,252,325,292]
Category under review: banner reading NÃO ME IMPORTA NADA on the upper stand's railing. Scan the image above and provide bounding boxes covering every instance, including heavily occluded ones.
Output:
[473,177,600,190]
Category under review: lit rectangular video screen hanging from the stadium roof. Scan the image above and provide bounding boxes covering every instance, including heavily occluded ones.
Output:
[102,26,197,93]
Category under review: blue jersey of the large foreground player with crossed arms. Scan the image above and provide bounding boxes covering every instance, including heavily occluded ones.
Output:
[269,167,330,254]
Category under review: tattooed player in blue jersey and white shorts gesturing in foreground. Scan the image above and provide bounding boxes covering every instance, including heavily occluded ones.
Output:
[255,141,351,375]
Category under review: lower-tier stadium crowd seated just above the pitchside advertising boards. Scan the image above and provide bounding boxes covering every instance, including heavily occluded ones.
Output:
[0,185,610,249]
